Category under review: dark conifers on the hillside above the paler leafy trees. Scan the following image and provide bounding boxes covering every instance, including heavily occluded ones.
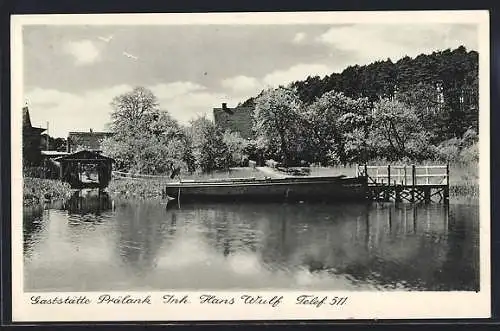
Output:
[243,46,479,142]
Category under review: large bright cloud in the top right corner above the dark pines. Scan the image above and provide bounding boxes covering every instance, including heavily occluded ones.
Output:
[316,24,477,64]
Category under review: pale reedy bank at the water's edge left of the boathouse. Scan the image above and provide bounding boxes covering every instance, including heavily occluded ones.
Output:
[23,177,71,207]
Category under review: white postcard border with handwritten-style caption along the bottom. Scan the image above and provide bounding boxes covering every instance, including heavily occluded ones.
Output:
[11,11,491,322]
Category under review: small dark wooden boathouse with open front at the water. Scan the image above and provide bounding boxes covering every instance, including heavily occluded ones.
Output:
[55,150,115,189]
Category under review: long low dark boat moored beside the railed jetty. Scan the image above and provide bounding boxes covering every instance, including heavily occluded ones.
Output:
[164,176,367,202]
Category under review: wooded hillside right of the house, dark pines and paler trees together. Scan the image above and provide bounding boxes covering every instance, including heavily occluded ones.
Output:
[243,47,479,164]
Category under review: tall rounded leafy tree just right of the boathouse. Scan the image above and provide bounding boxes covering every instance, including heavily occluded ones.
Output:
[103,87,194,174]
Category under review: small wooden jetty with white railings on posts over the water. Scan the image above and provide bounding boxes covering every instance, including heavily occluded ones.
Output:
[356,164,450,204]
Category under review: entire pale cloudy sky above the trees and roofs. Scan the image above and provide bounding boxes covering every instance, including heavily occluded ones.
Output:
[22,22,478,137]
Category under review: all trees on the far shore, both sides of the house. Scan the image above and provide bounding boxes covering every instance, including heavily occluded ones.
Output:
[104,47,479,174]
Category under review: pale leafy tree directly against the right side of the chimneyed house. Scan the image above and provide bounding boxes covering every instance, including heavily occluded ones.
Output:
[254,86,302,166]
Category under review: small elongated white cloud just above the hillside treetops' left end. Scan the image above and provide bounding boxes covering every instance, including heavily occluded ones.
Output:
[263,64,333,87]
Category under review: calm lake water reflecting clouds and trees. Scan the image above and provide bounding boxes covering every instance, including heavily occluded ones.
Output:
[24,194,479,291]
